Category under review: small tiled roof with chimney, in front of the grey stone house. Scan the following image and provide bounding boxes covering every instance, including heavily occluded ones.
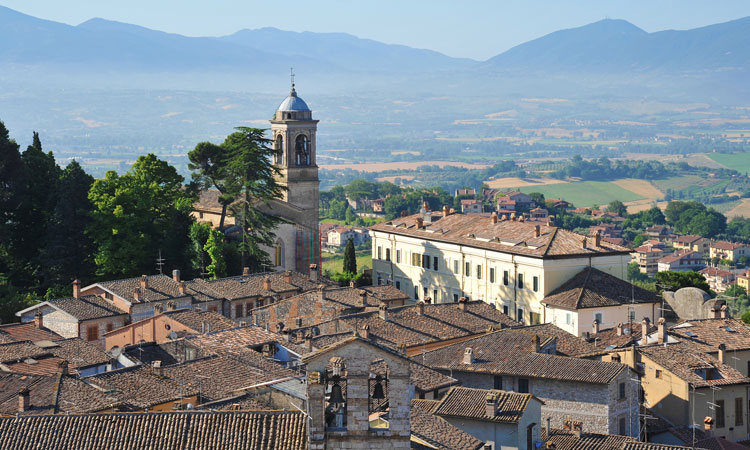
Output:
[435,387,534,423]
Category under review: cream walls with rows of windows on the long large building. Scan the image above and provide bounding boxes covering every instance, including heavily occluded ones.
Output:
[371,231,630,324]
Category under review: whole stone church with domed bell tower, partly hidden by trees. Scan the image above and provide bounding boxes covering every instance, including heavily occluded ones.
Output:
[193,81,320,273]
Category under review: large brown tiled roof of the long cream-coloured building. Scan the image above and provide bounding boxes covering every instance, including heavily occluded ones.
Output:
[370,212,630,258]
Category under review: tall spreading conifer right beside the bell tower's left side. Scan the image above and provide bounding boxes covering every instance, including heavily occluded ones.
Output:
[222,127,285,270]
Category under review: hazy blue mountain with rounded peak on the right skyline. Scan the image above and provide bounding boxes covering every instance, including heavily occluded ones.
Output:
[485,17,750,73]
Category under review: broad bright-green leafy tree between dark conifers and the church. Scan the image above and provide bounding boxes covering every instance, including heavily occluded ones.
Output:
[89,154,194,278]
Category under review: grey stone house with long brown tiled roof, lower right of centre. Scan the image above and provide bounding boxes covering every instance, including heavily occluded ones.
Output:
[415,329,640,436]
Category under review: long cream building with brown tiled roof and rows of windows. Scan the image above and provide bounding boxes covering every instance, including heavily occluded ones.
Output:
[370,210,630,324]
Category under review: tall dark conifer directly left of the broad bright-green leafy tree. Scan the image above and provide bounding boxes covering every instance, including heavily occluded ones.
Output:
[42,160,95,289]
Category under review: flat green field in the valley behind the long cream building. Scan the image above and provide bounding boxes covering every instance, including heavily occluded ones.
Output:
[520,181,645,207]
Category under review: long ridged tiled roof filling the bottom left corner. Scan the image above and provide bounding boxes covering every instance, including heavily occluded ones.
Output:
[0,411,307,450]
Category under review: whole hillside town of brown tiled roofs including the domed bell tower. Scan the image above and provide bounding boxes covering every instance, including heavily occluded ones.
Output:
[0,84,750,450]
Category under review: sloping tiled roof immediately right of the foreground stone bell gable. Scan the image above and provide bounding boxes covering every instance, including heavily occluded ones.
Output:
[411,400,484,450]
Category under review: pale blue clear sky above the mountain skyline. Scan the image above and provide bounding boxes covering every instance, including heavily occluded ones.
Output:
[0,0,750,59]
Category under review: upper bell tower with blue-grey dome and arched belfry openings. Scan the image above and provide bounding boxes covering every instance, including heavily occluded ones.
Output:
[270,73,320,232]
